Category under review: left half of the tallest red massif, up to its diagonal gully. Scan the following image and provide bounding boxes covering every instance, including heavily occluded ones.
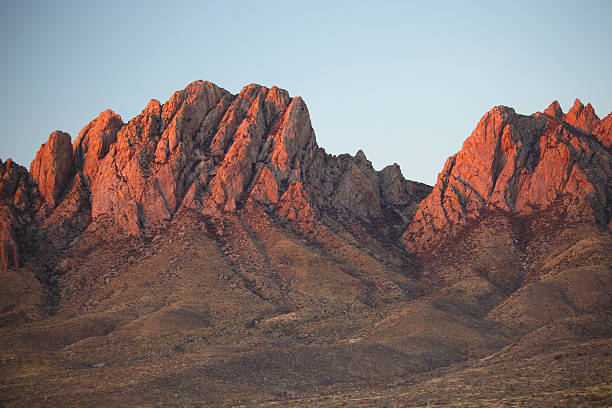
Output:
[91,81,232,235]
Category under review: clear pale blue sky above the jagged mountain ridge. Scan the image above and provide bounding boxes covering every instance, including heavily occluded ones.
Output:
[0,0,612,184]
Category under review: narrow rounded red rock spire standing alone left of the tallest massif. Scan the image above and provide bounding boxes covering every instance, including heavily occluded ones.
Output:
[30,130,73,207]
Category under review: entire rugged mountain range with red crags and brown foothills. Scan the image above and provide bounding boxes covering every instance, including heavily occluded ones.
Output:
[0,81,612,407]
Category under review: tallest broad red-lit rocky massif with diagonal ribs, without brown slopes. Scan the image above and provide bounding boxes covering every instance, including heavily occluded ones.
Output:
[77,81,318,234]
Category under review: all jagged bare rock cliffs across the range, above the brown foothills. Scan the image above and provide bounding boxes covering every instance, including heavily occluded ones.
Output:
[2,81,612,259]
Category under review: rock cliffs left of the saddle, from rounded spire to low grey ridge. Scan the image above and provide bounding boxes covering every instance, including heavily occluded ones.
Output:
[9,81,429,242]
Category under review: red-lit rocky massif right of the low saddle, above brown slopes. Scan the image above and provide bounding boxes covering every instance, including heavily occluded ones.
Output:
[404,100,612,254]
